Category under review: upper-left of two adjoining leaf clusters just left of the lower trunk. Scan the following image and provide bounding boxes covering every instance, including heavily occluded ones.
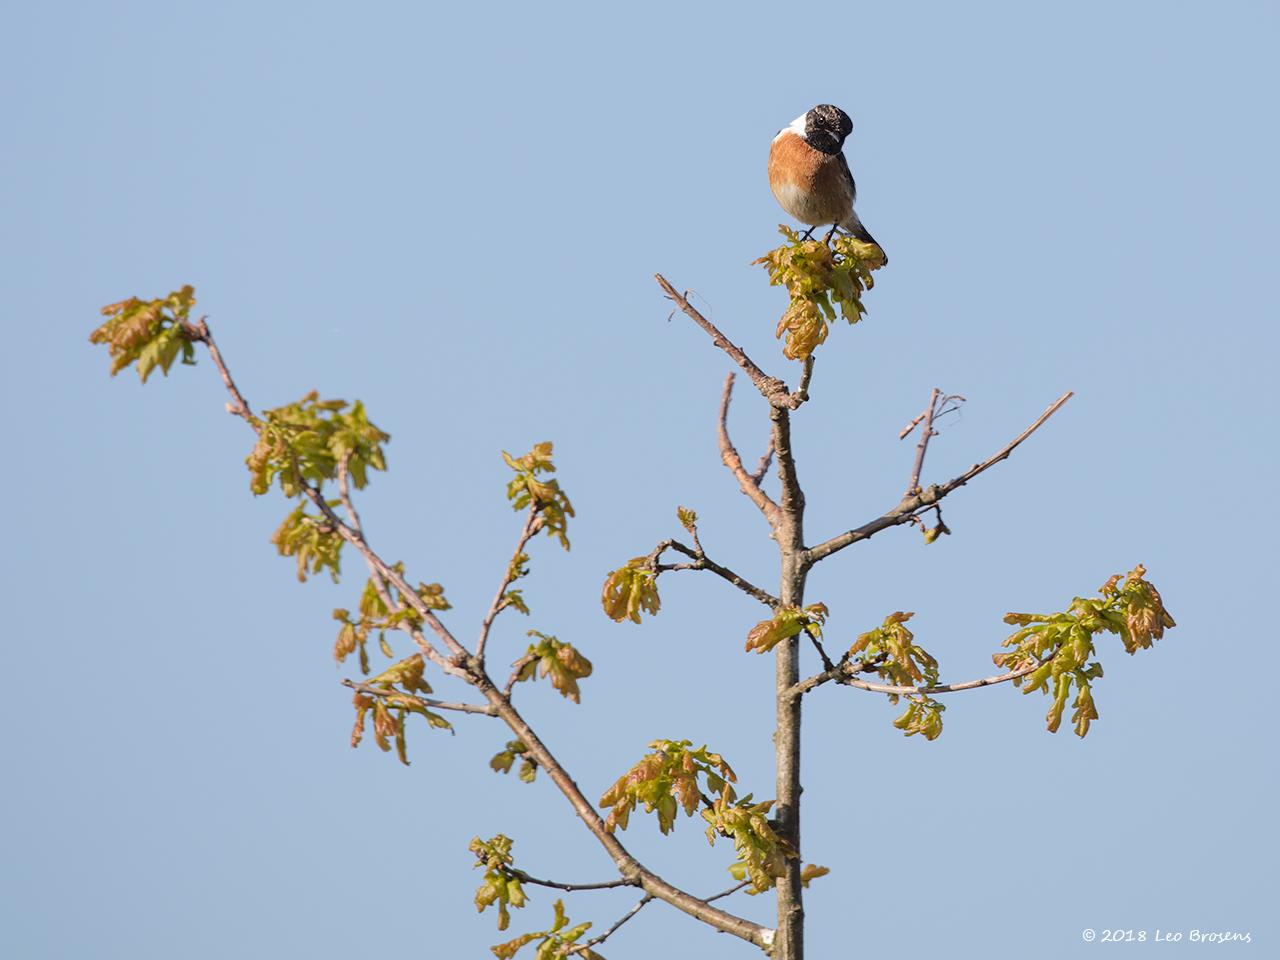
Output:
[600,740,737,833]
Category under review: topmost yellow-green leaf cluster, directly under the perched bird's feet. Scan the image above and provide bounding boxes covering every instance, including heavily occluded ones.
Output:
[753,227,884,360]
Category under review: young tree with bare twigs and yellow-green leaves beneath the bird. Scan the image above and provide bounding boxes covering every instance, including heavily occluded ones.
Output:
[91,228,1174,960]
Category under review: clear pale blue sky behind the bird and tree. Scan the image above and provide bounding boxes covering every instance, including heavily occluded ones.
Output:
[0,3,1277,960]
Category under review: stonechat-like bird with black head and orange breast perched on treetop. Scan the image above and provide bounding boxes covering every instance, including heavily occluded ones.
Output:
[769,104,888,264]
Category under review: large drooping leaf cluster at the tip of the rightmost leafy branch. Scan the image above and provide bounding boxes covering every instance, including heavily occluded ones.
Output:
[991,563,1176,737]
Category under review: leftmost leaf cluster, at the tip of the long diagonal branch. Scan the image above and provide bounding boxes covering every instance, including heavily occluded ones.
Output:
[88,284,196,383]
